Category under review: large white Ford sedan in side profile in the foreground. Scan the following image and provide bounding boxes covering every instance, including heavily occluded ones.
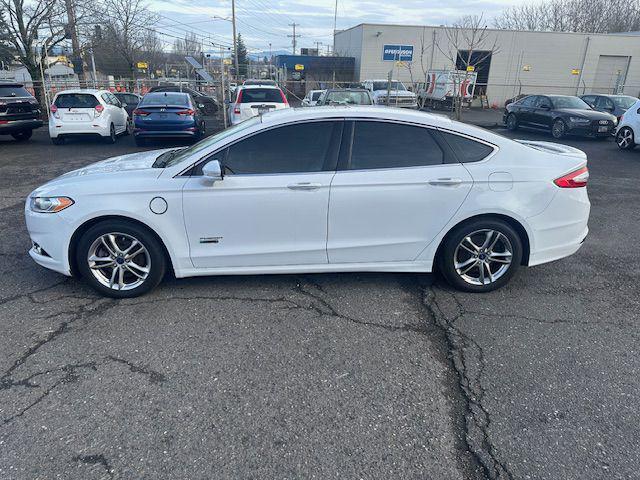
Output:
[25,107,590,297]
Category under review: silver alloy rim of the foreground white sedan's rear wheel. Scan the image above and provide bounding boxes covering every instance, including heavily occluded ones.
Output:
[453,229,513,285]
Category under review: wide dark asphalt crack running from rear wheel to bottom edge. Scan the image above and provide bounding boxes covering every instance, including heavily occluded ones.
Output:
[423,286,513,480]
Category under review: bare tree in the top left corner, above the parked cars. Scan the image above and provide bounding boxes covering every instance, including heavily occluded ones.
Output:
[0,0,65,103]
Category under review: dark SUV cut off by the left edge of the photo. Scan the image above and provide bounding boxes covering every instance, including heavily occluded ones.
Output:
[0,82,42,141]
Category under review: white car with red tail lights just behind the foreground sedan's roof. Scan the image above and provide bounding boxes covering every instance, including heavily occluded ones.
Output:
[229,85,289,125]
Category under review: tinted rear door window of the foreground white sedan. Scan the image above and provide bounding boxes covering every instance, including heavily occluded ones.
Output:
[349,121,444,170]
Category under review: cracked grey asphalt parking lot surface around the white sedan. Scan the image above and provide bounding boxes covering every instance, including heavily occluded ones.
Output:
[0,118,640,479]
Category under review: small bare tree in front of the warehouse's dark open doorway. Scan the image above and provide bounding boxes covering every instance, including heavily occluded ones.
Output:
[436,15,500,120]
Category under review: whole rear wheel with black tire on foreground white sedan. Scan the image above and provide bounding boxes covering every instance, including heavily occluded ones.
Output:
[437,218,522,293]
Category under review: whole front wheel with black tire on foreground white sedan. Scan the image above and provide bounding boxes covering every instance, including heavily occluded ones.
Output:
[76,220,167,298]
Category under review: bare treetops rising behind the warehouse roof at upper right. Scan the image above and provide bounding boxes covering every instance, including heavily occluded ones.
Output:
[494,0,640,33]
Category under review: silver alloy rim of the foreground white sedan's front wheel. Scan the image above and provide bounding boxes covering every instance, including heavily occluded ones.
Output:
[87,232,151,290]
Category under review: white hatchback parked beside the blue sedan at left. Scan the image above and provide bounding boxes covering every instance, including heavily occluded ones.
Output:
[49,89,129,145]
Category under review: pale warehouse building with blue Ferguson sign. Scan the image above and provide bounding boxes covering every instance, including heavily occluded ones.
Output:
[334,24,640,106]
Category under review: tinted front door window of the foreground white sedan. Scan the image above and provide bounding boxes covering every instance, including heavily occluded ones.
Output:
[224,122,334,175]
